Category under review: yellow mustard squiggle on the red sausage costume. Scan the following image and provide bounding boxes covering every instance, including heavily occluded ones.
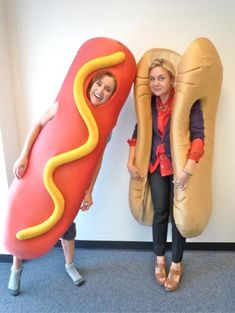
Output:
[16,51,125,240]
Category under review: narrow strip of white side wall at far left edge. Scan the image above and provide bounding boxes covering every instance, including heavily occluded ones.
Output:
[0,0,20,253]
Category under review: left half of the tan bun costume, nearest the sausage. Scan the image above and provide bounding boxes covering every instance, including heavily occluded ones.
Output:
[129,49,181,225]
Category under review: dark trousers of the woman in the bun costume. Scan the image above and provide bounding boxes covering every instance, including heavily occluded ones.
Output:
[149,167,186,263]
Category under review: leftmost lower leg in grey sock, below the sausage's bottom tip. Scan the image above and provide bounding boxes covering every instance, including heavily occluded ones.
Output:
[8,256,23,296]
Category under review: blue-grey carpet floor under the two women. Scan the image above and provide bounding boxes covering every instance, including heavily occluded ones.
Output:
[0,248,235,313]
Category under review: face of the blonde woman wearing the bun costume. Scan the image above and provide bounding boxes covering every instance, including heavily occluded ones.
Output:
[149,66,174,101]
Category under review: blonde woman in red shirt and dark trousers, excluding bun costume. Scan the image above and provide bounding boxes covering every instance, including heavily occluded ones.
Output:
[128,58,204,291]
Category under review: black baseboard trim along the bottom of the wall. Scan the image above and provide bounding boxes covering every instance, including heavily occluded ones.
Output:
[0,240,235,263]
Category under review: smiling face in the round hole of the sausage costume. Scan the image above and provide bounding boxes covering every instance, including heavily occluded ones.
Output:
[89,75,115,105]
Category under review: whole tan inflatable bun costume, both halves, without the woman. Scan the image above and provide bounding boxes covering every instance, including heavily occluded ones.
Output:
[129,38,222,237]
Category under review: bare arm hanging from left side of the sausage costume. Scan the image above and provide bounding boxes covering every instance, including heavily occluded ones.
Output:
[13,102,58,179]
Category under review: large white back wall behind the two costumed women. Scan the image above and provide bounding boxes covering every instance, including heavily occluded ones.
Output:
[0,0,235,254]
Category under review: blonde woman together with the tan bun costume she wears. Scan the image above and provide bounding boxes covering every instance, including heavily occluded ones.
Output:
[128,38,222,291]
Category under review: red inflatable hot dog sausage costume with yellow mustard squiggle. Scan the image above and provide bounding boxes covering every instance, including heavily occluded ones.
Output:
[4,37,136,259]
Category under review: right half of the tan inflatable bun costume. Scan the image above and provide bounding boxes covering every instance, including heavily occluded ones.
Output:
[171,38,222,237]
